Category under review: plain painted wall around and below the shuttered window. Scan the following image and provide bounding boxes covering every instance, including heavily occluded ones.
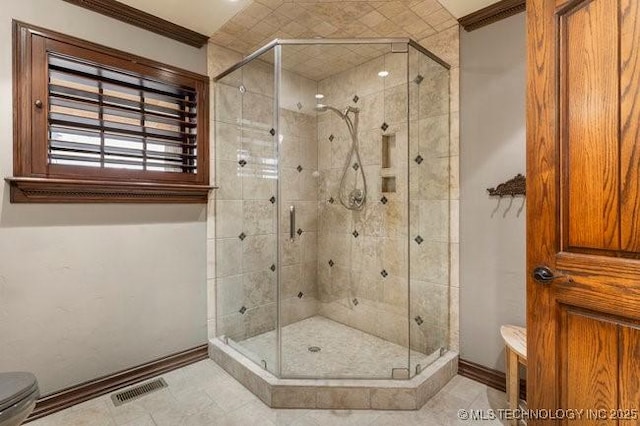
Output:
[0,0,207,393]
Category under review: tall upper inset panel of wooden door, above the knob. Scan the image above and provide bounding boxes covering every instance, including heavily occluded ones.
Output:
[558,0,619,250]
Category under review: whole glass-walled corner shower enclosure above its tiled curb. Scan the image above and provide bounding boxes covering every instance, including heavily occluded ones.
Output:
[215,39,449,379]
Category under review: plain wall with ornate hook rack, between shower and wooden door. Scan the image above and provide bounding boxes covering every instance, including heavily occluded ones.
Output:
[460,14,526,370]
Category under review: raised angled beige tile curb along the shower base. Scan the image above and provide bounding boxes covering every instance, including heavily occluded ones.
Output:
[209,338,458,410]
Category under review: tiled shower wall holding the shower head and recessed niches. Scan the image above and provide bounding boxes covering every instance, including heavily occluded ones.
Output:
[318,48,449,353]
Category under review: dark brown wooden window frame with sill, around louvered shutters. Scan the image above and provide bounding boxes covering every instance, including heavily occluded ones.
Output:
[5,20,212,203]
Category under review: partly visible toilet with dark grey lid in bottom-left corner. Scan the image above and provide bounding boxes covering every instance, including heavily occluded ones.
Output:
[0,373,40,426]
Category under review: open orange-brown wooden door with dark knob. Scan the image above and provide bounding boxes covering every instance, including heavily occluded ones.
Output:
[527,0,640,425]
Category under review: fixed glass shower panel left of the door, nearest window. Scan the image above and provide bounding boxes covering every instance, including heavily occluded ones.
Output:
[215,45,278,374]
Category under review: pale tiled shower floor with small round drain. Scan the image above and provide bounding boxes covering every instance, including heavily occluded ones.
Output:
[234,316,439,379]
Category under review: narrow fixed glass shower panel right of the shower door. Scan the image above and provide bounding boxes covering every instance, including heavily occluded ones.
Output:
[408,51,451,353]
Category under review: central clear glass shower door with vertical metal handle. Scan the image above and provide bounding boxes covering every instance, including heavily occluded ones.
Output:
[276,42,409,379]
